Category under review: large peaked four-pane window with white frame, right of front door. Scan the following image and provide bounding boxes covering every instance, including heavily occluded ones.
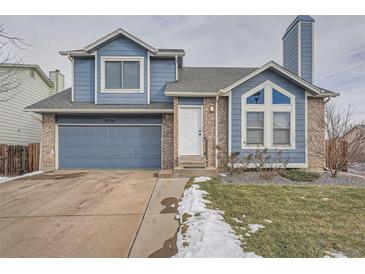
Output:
[241,81,295,149]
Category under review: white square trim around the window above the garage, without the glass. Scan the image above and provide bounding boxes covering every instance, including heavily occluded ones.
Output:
[100,56,144,93]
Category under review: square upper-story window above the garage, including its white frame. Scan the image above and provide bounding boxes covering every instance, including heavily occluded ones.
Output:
[101,57,143,93]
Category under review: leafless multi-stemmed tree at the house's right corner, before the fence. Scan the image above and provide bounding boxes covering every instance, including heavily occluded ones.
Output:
[308,103,365,177]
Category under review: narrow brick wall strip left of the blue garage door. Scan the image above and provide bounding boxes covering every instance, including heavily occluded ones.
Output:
[41,114,56,171]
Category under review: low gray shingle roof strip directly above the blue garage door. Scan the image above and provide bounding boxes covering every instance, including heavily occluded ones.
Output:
[25,88,173,112]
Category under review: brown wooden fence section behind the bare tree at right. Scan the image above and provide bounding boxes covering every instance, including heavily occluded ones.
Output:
[325,140,348,171]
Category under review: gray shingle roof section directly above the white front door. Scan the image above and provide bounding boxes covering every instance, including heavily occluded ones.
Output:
[165,67,257,93]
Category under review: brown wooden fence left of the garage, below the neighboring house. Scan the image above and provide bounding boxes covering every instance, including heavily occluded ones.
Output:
[0,144,40,176]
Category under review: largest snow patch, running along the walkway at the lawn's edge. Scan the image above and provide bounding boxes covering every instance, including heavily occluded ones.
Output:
[174,184,260,258]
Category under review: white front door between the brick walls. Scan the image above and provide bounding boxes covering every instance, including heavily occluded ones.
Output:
[178,106,203,155]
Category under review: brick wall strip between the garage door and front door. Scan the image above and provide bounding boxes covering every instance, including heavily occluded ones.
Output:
[161,114,174,169]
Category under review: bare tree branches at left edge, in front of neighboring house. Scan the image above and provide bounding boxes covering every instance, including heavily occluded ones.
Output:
[0,23,30,102]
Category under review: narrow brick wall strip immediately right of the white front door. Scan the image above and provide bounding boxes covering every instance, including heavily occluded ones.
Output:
[203,97,216,167]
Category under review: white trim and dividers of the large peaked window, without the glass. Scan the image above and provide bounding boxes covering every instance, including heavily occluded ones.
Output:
[241,81,296,150]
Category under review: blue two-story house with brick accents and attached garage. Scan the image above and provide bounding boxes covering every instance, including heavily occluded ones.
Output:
[27,16,337,175]
